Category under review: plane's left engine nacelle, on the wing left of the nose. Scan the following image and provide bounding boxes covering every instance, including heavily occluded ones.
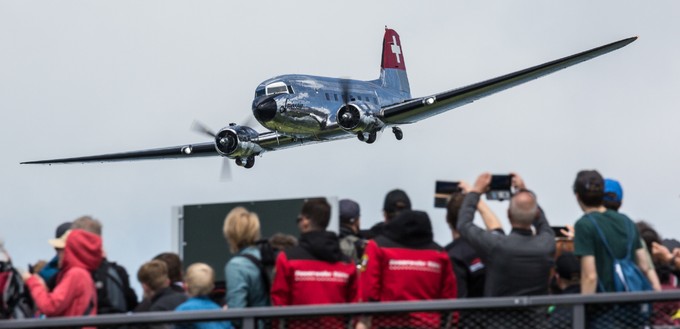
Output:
[215,123,262,159]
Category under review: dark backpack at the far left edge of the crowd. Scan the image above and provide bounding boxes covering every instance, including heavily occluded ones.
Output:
[0,261,36,319]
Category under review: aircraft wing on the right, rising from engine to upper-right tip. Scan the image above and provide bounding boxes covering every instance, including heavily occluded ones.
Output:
[381,37,637,125]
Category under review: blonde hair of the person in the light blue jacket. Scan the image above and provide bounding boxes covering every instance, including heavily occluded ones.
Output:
[222,207,260,253]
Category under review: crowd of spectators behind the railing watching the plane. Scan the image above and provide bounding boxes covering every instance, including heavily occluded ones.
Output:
[5,170,680,328]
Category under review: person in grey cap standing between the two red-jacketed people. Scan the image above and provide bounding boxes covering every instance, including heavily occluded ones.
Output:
[338,199,366,263]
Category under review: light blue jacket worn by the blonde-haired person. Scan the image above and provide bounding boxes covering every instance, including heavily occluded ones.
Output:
[224,246,269,308]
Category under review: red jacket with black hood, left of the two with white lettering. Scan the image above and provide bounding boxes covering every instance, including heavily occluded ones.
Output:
[271,231,358,306]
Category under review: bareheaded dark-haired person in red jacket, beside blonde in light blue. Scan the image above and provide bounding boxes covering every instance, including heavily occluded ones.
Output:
[271,198,358,328]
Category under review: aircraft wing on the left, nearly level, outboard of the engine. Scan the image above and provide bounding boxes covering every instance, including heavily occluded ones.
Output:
[21,142,218,164]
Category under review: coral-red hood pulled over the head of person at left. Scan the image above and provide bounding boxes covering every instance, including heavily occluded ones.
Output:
[62,230,102,273]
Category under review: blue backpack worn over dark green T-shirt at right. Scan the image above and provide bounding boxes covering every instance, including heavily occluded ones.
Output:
[588,215,652,292]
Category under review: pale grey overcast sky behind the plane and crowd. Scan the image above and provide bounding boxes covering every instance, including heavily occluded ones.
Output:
[0,0,680,292]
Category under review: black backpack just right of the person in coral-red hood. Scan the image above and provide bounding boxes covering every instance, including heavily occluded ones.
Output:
[92,259,129,314]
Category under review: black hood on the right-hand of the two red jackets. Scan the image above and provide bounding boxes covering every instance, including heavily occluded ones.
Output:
[382,210,434,247]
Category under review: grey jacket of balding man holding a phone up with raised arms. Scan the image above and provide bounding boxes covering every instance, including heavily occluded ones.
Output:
[457,192,555,297]
